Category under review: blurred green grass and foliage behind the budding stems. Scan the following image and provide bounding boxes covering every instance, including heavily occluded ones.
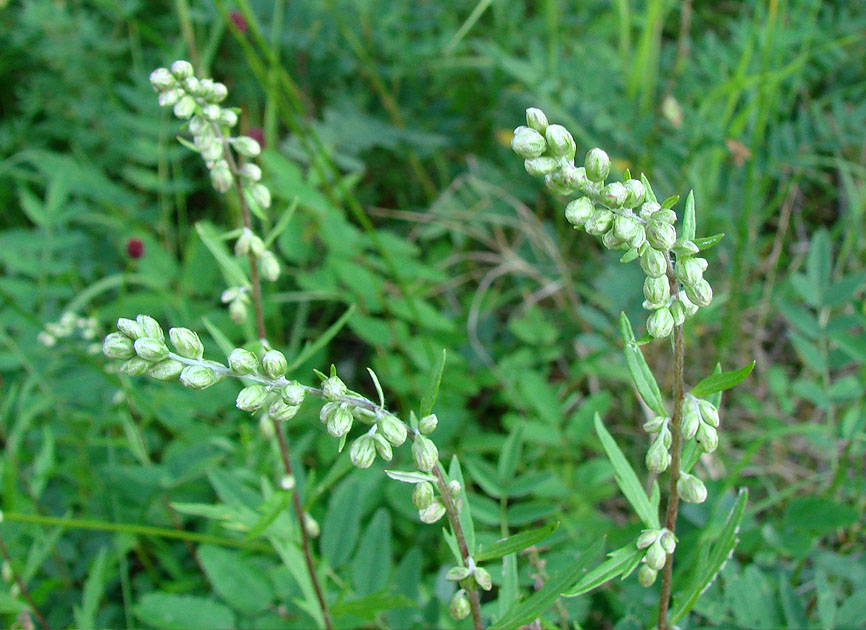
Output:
[0,0,866,629]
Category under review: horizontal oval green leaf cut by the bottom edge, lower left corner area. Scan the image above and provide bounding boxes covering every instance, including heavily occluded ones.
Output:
[134,591,235,630]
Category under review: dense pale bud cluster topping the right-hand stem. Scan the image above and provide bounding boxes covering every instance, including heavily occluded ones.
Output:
[511,108,713,338]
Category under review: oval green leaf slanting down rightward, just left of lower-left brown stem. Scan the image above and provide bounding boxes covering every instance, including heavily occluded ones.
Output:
[198,545,274,615]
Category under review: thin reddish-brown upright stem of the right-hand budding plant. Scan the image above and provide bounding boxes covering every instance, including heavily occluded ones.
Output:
[656,258,685,630]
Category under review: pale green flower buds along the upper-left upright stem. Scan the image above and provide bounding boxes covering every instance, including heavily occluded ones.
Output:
[150,60,280,323]
